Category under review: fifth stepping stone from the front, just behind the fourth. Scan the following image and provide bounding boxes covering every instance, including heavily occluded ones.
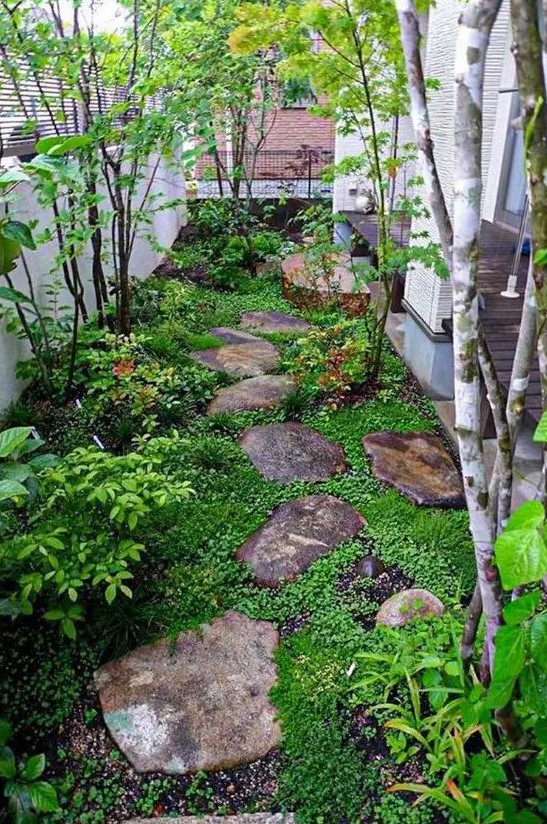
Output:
[190,338,279,378]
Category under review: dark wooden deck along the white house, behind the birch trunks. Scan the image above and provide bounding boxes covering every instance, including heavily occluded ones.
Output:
[344,212,542,421]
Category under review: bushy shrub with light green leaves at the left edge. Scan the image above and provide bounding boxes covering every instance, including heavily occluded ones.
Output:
[0,441,195,638]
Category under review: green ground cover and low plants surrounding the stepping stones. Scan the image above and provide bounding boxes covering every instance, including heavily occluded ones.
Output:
[0,204,545,824]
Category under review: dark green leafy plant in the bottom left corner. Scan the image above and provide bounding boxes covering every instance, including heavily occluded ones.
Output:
[0,719,58,824]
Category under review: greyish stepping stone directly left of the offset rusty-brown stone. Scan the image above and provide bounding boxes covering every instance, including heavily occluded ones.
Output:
[239,422,346,483]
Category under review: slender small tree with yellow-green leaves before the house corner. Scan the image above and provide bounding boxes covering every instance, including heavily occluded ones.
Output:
[230,0,448,376]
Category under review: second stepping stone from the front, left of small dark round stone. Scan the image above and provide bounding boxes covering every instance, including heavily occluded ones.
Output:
[237,495,365,587]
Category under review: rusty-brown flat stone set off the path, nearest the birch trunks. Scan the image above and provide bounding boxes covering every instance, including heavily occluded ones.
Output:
[363,432,465,508]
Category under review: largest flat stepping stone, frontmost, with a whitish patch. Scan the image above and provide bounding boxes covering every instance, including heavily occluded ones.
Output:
[95,611,281,774]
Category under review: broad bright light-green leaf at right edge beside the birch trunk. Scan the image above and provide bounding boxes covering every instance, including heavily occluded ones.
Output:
[495,528,547,590]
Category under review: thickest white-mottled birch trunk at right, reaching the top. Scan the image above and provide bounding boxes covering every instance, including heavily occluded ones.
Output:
[452,0,501,670]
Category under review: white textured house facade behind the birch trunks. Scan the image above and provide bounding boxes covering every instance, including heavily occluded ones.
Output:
[335,0,526,398]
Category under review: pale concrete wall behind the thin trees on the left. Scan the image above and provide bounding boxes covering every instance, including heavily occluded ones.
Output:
[0,157,185,411]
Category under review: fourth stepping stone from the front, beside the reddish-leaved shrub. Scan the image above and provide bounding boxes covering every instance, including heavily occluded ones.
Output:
[207,375,296,415]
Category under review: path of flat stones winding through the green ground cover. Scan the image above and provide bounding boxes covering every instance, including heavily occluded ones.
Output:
[95,306,464,784]
